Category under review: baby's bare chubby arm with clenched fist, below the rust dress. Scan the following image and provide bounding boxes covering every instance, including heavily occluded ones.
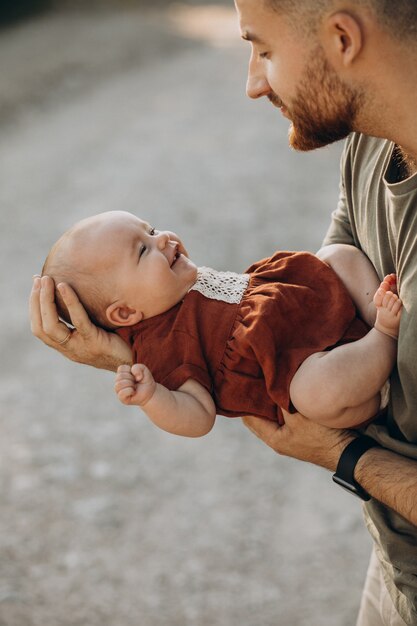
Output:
[115,363,216,437]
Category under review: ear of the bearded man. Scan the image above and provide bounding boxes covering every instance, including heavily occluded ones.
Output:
[320,11,364,71]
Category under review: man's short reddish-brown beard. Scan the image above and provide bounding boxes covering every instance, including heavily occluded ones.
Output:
[282,47,363,151]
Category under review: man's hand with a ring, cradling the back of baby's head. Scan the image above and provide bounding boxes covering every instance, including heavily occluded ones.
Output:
[29,276,132,371]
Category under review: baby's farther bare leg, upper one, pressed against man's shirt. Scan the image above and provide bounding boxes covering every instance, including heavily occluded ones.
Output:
[316,243,384,326]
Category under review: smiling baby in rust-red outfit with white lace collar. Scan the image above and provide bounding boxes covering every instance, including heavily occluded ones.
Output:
[43,211,402,437]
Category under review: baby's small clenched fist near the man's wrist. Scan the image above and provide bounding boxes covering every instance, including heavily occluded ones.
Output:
[114,363,156,406]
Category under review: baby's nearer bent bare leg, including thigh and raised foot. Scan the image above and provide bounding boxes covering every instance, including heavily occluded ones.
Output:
[290,279,401,428]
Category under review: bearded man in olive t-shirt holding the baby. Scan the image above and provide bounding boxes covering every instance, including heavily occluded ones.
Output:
[31,0,417,626]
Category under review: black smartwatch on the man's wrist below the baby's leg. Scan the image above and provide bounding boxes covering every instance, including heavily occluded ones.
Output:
[333,435,380,500]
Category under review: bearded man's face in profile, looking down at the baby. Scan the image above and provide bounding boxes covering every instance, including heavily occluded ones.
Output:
[235,0,361,150]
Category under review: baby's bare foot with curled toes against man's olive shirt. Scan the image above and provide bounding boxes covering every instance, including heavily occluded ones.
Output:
[374,274,403,339]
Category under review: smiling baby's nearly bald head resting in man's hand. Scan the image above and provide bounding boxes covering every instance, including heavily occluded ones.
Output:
[42,211,197,330]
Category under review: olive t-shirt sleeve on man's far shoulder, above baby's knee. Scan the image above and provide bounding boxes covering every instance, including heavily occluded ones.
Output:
[323,135,355,246]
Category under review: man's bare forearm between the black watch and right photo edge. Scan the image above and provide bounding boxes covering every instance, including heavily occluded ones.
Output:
[355,448,417,526]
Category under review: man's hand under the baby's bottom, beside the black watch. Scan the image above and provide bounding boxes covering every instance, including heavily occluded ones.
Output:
[243,411,355,471]
